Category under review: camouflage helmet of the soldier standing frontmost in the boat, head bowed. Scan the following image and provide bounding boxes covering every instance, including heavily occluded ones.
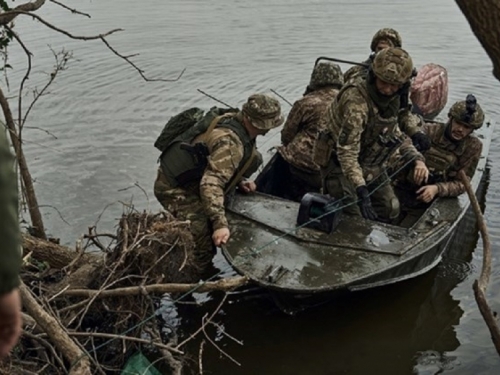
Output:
[372,47,413,85]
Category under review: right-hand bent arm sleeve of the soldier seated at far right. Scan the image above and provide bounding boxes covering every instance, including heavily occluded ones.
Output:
[436,137,483,197]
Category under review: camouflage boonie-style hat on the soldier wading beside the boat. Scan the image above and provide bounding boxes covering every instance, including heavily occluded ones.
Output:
[242,94,284,130]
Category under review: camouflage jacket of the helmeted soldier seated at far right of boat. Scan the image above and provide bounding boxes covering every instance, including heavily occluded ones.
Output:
[423,123,483,197]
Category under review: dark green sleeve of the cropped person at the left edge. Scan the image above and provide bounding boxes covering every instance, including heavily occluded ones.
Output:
[0,124,21,294]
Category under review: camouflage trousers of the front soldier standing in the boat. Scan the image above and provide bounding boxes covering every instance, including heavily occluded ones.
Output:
[322,164,400,221]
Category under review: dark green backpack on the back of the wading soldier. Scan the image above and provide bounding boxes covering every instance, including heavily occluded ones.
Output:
[154,107,238,152]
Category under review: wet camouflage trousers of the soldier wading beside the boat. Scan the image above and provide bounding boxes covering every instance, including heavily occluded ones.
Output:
[154,167,216,272]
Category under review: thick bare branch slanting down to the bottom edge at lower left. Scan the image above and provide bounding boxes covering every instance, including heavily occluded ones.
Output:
[19,282,91,375]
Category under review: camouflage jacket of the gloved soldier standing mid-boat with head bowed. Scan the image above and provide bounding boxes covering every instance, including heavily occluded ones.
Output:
[326,83,424,187]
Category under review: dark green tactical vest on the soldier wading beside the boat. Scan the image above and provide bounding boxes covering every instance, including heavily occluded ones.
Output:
[160,117,256,192]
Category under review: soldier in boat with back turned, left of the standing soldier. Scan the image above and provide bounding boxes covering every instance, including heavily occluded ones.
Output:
[278,63,343,201]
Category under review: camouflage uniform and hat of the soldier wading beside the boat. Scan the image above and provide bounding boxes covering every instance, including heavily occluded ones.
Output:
[154,94,283,269]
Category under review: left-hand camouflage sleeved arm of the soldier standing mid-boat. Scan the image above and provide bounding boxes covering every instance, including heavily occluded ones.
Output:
[337,90,368,188]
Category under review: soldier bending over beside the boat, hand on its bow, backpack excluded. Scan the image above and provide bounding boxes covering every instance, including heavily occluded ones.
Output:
[154,94,283,276]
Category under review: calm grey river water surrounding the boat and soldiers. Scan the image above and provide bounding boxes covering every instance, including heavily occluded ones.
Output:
[9,0,500,375]
